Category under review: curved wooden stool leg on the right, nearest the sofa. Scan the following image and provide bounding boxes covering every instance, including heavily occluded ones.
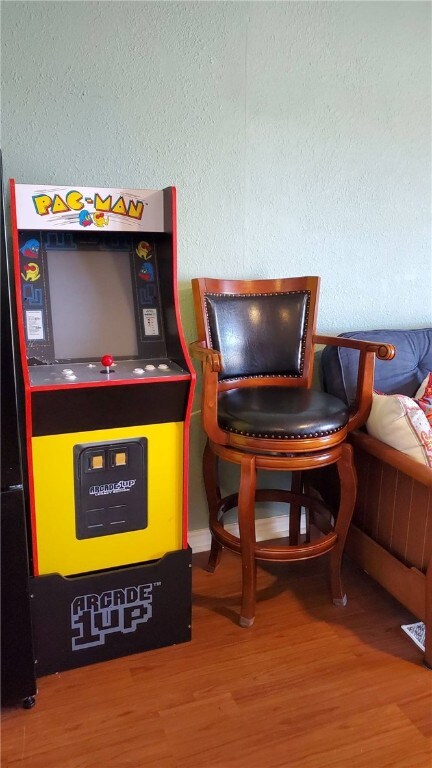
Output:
[330,443,357,605]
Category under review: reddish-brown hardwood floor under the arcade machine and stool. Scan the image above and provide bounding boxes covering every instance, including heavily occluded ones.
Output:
[2,552,432,768]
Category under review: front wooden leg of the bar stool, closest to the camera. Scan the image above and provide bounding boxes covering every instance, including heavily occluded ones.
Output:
[238,456,256,627]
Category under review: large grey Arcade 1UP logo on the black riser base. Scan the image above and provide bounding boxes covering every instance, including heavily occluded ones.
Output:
[71,582,156,651]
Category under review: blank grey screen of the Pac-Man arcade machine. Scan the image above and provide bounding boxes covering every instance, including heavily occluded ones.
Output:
[47,248,138,360]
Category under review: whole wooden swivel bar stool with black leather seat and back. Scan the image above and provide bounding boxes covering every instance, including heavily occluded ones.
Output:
[190,277,394,627]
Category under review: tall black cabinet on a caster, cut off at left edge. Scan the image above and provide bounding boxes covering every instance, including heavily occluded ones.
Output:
[0,154,36,708]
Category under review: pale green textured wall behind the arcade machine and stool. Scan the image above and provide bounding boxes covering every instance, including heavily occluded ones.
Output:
[2,1,432,528]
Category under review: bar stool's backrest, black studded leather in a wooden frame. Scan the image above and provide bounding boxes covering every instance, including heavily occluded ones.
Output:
[192,277,320,391]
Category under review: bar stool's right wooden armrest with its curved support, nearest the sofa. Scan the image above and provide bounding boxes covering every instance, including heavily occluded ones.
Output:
[313,335,396,432]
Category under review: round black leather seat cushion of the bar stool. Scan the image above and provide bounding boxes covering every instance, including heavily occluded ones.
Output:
[218,386,348,439]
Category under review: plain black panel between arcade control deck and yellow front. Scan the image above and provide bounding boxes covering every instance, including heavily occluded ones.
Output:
[32,380,191,437]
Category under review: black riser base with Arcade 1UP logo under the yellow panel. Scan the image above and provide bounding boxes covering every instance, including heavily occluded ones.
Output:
[30,547,192,677]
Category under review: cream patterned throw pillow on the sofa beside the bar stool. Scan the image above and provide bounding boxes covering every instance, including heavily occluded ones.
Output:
[366,392,432,467]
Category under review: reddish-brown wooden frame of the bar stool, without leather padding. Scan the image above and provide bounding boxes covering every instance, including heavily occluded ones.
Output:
[190,277,395,627]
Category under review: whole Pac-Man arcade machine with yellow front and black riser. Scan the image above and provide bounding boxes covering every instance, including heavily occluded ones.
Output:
[11,181,195,675]
